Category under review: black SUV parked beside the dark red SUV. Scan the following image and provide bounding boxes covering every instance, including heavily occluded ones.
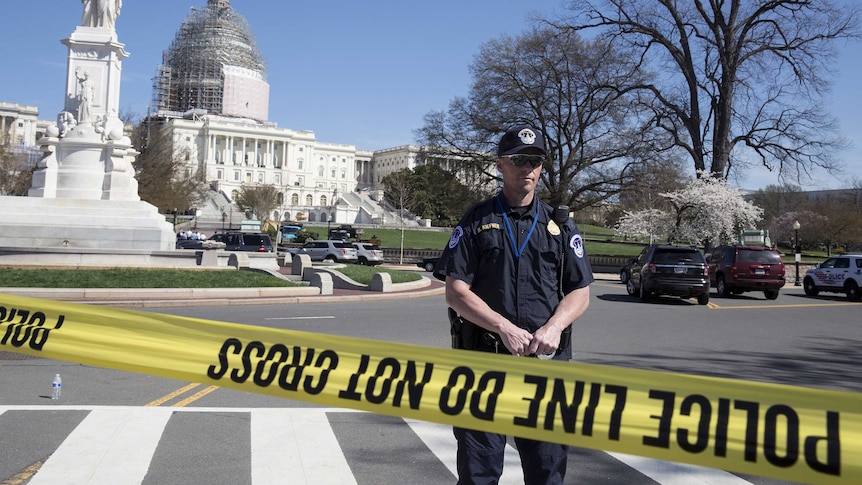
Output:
[626,245,709,305]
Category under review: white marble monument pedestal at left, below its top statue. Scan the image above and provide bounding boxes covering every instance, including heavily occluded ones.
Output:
[0,27,176,251]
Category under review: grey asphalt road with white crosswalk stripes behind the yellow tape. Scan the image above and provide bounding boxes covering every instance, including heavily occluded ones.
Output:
[0,274,862,485]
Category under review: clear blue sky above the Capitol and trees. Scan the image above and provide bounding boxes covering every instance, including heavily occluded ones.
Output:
[0,0,862,189]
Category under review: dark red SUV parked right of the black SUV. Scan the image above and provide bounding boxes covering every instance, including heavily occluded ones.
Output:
[707,245,785,300]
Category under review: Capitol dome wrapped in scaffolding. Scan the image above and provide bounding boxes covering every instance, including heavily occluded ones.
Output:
[153,0,269,122]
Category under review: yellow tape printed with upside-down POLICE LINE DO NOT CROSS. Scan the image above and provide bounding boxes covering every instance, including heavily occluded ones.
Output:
[0,295,862,484]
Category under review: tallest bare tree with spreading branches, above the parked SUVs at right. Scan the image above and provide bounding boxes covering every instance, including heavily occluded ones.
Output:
[568,0,859,181]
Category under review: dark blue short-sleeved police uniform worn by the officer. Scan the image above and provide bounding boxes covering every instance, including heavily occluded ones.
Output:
[434,195,593,484]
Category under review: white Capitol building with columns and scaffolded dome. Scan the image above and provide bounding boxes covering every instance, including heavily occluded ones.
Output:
[5,0,451,225]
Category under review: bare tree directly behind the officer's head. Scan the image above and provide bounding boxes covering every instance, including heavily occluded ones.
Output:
[417,26,654,211]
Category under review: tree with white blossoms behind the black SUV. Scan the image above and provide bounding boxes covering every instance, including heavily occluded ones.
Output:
[616,172,763,246]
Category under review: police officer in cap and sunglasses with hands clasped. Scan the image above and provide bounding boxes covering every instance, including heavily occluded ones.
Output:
[435,126,593,485]
